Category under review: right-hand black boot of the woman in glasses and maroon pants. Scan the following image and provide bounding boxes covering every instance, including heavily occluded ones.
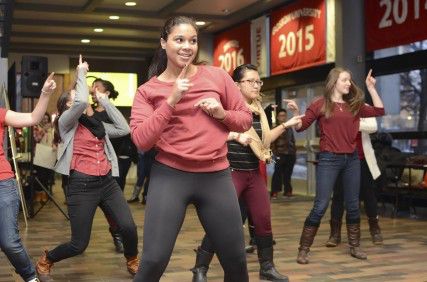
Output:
[256,235,289,282]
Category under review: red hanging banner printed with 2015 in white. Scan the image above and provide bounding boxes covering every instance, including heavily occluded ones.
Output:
[270,0,326,75]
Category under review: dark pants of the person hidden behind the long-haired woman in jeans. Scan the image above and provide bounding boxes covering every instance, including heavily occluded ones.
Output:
[331,159,378,221]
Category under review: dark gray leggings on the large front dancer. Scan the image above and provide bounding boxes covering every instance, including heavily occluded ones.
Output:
[134,162,249,282]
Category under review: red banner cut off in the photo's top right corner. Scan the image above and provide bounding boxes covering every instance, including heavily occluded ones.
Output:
[365,0,427,51]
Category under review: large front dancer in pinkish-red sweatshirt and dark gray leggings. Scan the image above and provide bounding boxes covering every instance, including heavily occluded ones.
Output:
[130,16,252,282]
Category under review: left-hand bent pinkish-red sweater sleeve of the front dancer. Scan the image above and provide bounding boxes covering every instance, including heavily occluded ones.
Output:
[130,88,174,151]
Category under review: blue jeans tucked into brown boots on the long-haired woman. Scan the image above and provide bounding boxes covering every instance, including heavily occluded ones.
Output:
[305,151,360,226]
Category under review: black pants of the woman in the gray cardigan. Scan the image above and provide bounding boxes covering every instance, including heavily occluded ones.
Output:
[47,171,138,262]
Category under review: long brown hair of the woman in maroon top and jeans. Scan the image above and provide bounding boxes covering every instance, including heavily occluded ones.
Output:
[322,67,365,118]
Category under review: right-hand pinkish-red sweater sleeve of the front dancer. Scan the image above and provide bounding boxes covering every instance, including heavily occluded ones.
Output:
[221,70,252,132]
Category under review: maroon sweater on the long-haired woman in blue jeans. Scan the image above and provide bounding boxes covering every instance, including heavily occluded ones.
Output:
[297,98,384,153]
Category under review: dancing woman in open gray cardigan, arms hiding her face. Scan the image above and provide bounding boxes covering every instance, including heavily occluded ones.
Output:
[36,56,139,280]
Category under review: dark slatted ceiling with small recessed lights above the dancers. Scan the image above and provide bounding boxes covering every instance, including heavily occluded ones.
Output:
[8,0,289,58]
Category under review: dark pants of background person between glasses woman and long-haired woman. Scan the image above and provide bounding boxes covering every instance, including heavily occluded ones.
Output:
[271,154,297,194]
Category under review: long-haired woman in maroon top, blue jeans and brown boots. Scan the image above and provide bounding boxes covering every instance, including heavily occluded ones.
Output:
[286,67,384,264]
